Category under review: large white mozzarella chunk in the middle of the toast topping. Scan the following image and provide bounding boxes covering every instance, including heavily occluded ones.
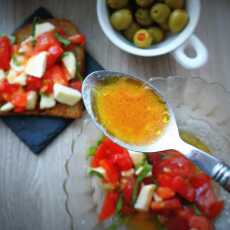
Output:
[25,51,48,78]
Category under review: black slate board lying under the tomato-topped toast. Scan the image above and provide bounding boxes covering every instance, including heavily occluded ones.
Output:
[2,7,103,154]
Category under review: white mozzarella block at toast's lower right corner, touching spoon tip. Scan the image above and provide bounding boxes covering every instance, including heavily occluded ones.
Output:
[54,83,81,106]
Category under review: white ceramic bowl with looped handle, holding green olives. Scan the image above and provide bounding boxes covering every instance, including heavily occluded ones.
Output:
[97,0,208,69]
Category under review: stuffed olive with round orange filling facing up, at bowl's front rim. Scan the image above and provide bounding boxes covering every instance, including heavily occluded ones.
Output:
[133,29,153,48]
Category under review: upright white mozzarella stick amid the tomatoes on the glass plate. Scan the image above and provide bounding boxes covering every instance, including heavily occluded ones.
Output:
[134,184,156,212]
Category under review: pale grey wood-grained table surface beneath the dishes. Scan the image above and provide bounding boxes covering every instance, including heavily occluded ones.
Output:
[0,0,230,230]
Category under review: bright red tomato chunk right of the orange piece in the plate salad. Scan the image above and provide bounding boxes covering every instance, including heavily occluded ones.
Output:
[171,176,195,202]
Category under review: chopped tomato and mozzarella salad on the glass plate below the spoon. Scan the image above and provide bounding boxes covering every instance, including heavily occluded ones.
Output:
[88,137,224,230]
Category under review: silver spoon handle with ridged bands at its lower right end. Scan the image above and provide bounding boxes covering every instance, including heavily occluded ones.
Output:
[178,142,230,192]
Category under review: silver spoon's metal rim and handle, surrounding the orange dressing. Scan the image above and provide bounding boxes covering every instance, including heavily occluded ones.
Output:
[82,70,230,192]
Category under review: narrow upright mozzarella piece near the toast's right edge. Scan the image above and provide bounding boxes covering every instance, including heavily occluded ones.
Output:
[62,52,77,80]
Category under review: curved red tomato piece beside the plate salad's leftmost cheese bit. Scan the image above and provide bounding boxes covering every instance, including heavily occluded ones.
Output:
[99,160,119,184]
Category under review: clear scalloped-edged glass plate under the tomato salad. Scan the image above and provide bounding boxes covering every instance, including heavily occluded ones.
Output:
[64,76,230,230]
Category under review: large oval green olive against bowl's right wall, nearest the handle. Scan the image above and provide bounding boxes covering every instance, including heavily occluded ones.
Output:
[169,9,189,33]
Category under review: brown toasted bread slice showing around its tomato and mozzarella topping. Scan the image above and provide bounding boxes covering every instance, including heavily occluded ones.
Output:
[0,19,85,119]
